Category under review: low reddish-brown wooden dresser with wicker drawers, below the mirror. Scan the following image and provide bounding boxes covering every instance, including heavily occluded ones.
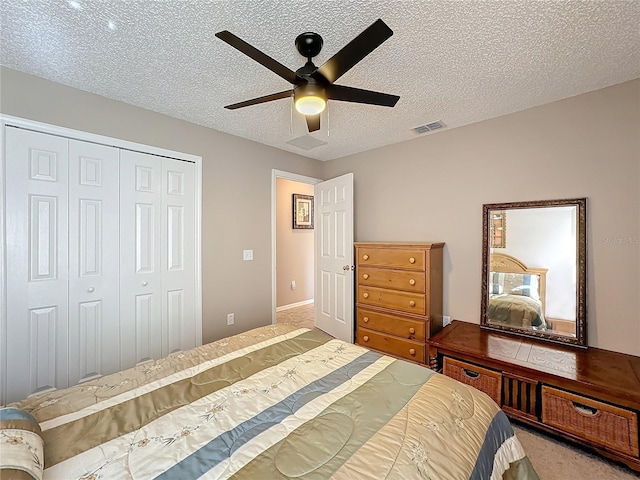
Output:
[429,320,640,471]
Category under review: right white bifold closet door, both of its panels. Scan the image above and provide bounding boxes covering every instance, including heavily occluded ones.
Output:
[120,150,196,368]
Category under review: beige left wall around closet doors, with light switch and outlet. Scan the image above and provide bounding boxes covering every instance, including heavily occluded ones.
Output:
[0,68,322,342]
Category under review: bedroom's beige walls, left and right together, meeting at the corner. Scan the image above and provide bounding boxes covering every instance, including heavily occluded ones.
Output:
[0,68,640,355]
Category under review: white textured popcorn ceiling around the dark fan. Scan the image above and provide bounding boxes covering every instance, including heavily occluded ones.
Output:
[0,0,640,160]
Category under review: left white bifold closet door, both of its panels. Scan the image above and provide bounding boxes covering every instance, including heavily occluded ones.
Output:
[5,128,120,401]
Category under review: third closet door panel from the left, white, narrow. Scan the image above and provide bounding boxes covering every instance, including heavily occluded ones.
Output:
[120,150,166,368]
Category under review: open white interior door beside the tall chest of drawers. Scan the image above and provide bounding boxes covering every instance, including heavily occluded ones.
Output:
[314,173,354,343]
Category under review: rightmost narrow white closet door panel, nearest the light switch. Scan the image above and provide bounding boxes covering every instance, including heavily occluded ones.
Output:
[161,158,196,355]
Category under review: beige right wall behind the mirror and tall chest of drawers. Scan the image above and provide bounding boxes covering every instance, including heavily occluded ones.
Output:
[324,80,640,355]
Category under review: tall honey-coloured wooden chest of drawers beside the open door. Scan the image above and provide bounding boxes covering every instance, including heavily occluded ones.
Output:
[355,242,444,364]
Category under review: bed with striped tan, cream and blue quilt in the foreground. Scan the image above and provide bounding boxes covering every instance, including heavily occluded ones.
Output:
[0,325,538,480]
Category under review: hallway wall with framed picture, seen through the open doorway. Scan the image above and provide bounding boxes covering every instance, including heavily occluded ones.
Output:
[276,178,313,307]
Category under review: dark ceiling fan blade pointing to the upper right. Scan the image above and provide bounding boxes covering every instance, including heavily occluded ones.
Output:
[316,19,393,83]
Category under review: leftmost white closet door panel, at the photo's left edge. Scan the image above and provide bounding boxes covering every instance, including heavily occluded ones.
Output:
[3,127,68,402]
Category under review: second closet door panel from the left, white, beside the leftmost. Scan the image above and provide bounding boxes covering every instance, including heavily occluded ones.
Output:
[69,140,120,385]
